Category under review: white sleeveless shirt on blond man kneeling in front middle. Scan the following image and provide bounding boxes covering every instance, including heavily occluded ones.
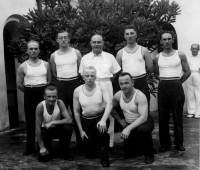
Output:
[79,82,105,115]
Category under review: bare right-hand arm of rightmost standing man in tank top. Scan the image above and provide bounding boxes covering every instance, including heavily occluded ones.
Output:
[178,51,191,83]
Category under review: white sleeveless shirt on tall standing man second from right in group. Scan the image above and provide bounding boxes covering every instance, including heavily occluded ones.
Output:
[122,46,146,77]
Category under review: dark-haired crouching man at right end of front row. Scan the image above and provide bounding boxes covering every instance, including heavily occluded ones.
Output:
[112,72,155,164]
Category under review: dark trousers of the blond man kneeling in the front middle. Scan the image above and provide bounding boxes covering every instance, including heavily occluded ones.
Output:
[82,116,110,159]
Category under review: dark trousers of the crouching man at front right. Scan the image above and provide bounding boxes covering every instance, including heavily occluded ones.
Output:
[124,115,155,157]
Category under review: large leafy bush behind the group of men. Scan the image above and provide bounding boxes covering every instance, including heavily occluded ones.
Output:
[8,0,180,97]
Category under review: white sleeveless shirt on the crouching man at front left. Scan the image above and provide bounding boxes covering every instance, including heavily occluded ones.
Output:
[41,100,61,127]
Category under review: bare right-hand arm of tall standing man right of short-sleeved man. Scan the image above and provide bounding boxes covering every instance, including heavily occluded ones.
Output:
[142,47,153,73]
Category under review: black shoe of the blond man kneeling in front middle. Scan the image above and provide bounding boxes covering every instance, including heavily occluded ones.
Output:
[99,147,110,167]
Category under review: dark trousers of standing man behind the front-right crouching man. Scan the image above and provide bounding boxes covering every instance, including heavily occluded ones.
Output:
[134,76,150,111]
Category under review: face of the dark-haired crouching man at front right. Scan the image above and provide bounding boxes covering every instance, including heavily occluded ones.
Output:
[119,75,133,93]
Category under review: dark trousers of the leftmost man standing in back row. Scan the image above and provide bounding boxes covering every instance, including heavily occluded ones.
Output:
[24,86,46,152]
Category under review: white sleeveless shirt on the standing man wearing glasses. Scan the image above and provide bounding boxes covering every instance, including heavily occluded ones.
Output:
[55,48,78,78]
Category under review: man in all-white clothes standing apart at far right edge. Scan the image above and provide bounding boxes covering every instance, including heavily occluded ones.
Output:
[187,44,200,118]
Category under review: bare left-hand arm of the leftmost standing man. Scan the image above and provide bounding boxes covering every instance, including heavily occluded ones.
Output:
[17,63,25,92]
